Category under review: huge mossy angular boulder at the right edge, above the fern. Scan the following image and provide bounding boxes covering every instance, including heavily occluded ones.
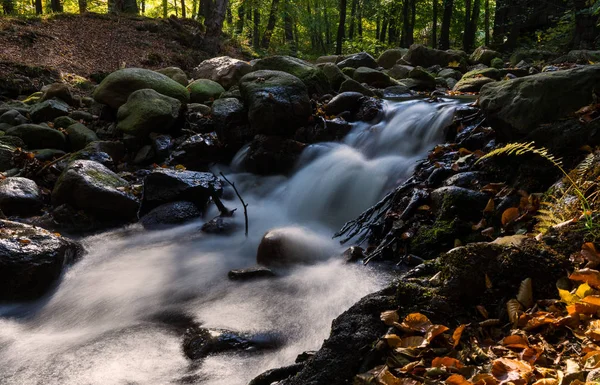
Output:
[479,65,600,134]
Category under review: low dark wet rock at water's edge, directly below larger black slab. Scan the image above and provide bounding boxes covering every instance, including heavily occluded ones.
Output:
[140,201,202,230]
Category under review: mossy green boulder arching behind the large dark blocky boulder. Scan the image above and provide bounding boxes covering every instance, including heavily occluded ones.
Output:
[252,56,331,95]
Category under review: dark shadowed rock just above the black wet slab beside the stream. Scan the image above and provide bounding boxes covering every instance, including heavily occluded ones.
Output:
[169,132,227,171]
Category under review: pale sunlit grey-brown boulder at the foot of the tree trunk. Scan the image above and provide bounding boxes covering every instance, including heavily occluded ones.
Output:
[192,56,252,89]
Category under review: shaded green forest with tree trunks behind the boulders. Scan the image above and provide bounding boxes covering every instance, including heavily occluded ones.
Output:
[0,0,600,58]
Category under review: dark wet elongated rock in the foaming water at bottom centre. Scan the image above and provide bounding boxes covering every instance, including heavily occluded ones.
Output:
[183,327,281,360]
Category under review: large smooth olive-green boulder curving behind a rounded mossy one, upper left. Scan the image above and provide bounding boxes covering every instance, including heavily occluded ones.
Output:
[93,68,190,109]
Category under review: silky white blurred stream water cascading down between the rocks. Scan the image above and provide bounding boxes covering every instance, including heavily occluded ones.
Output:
[0,101,456,385]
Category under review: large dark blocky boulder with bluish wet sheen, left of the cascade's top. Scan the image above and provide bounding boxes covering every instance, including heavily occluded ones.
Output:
[240,71,312,135]
